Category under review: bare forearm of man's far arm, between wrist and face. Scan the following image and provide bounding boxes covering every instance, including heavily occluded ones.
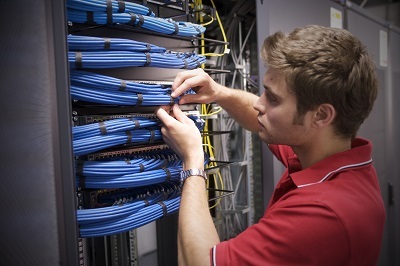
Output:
[216,85,259,132]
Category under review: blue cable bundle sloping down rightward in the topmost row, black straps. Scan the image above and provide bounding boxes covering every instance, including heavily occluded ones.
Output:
[67,8,206,37]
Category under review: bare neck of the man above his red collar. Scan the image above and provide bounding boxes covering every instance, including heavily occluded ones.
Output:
[292,137,351,169]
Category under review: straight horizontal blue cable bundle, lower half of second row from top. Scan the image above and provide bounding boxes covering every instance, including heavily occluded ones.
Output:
[68,51,206,69]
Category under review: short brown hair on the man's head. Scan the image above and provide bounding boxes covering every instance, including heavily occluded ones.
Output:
[261,25,378,139]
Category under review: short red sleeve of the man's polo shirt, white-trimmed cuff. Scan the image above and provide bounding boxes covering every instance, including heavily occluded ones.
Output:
[211,200,349,266]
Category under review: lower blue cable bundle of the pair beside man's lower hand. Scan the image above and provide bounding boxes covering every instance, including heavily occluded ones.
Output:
[73,129,162,156]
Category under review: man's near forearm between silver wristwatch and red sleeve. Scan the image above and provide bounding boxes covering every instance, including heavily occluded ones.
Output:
[178,176,220,266]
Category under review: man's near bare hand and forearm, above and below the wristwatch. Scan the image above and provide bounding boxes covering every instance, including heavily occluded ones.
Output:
[156,105,219,266]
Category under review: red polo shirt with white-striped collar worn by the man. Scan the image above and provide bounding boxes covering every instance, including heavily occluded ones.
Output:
[211,138,385,266]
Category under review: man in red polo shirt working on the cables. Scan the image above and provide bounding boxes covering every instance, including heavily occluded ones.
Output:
[156,26,385,265]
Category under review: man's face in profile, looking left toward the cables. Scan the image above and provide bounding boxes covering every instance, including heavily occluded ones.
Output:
[254,69,312,146]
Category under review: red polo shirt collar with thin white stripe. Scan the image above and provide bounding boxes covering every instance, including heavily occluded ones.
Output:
[288,138,372,187]
